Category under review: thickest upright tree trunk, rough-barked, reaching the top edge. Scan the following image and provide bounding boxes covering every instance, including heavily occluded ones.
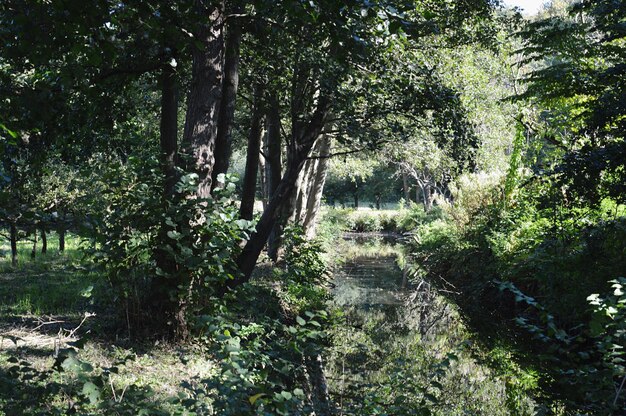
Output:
[183,1,225,198]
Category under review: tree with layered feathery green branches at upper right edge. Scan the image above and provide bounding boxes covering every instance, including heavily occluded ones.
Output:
[520,0,626,204]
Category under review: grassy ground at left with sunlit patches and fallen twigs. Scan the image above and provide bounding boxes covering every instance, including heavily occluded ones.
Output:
[0,235,215,416]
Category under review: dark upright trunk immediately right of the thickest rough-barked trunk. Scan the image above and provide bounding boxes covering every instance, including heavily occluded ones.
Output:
[211,19,241,189]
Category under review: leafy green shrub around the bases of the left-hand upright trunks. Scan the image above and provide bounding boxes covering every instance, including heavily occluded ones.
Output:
[93,157,252,326]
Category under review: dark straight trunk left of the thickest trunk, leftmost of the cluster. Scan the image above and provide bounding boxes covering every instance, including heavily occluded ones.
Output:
[160,63,178,201]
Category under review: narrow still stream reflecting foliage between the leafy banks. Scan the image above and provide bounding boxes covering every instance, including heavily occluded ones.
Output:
[328,236,534,416]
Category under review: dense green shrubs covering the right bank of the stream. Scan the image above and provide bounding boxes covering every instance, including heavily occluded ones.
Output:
[413,170,626,414]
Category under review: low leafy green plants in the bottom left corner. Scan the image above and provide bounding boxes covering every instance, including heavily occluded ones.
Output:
[0,339,182,416]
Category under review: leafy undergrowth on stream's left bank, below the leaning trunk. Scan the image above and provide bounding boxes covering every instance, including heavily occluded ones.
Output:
[181,228,333,415]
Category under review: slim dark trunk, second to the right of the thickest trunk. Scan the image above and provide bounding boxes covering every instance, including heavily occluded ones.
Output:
[239,85,263,220]
